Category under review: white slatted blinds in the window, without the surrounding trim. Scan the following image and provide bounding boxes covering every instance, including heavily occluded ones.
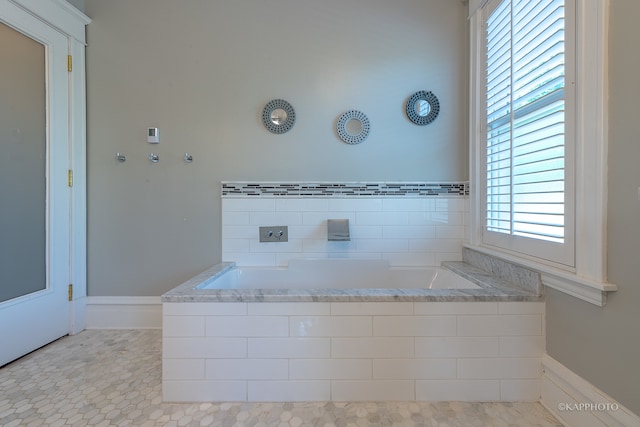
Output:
[485,0,566,249]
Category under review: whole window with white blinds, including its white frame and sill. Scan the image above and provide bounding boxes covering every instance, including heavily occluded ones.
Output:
[465,0,617,306]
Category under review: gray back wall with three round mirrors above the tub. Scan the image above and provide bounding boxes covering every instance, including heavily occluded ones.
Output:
[84,0,468,296]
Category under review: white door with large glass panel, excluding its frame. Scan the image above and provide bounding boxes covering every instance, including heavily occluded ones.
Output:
[0,3,70,366]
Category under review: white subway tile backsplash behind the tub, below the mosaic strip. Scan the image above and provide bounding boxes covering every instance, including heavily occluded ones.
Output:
[222,195,469,267]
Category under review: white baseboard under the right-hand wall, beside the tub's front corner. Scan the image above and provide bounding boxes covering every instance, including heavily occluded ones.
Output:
[540,354,640,427]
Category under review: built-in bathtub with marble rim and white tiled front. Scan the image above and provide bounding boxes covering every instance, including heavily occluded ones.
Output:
[162,259,544,401]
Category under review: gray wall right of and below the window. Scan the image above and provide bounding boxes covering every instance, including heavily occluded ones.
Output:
[547,0,640,414]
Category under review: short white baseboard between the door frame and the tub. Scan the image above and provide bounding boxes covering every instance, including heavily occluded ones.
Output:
[86,297,162,329]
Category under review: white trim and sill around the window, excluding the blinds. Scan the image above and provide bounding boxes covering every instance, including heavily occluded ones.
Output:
[467,0,617,306]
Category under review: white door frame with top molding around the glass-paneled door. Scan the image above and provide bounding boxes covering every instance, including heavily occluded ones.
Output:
[0,0,91,334]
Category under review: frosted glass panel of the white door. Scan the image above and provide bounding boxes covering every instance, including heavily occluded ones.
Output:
[0,23,47,302]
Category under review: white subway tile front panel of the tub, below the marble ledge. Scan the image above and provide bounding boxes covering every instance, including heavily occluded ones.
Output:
[162,302,545,402]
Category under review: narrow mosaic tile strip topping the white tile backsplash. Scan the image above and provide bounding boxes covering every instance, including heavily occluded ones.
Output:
[221,181,469,197]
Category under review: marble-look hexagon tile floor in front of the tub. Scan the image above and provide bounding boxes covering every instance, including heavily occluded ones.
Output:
[0,330,561,427]
